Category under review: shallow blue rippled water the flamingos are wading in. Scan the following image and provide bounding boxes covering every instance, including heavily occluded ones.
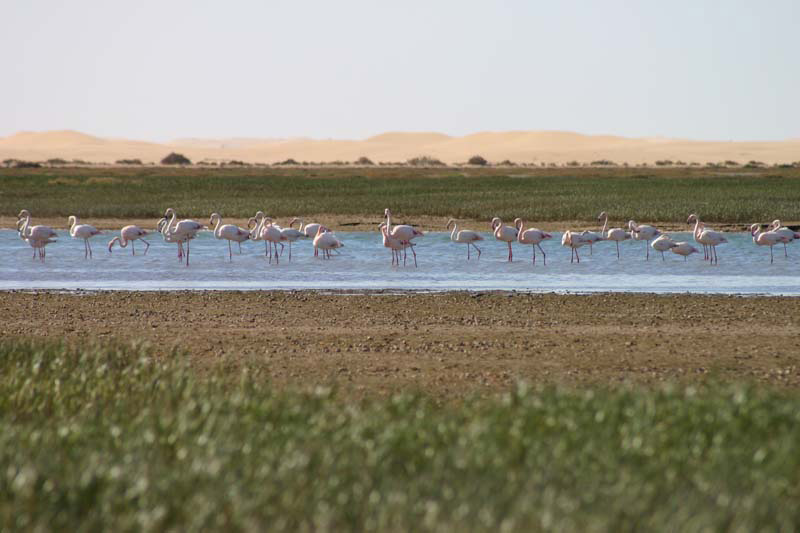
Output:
[0,230,800,295]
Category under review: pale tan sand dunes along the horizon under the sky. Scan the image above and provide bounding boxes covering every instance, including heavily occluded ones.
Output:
[0,131,800,164]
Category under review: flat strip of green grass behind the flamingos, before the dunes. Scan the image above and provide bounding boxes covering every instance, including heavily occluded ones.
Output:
[0,168,800,223]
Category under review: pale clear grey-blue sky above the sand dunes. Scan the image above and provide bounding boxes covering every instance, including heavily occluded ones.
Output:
[0,0,800,141]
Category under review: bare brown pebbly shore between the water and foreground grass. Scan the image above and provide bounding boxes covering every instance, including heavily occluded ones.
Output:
[0,291,800,396]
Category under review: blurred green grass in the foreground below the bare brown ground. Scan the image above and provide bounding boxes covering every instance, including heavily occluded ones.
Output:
[0,341,800,531]
